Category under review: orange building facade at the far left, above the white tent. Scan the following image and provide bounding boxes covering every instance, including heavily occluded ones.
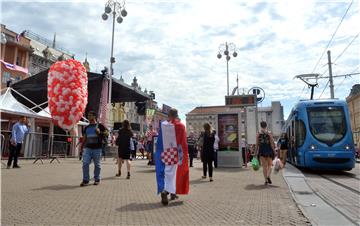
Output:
[1,24,32,88]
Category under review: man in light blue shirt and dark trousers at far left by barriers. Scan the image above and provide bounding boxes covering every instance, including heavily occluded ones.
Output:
[7,116,30,169]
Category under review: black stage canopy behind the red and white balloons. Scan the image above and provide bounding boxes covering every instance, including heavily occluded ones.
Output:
[11,70,150,115]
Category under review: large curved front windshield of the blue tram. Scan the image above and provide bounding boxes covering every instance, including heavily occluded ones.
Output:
[307,107,346,145]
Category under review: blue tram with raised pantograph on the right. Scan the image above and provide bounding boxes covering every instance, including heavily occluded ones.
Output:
[284,99,355,170]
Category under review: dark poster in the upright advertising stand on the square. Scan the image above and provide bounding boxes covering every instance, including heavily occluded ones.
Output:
[218,114,239,151]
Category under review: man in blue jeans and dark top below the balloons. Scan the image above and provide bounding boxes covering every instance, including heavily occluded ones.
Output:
[80,111,108,187]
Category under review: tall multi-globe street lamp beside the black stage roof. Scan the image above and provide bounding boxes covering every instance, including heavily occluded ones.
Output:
[101,0,127,125]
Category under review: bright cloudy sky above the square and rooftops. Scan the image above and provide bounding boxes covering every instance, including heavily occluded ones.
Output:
[1,0,360,122]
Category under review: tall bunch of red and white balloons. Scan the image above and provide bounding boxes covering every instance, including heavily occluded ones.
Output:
[48,59,88,130]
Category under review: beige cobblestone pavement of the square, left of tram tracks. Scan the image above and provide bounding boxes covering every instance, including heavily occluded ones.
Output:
[1,158,309,225]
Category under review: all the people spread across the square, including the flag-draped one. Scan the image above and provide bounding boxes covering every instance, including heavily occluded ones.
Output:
[7,109,289,205]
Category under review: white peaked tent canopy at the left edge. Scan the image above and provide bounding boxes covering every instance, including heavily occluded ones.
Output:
[0,88,51,119]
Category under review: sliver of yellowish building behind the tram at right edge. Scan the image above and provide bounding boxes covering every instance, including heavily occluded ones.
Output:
[346,84,360,148]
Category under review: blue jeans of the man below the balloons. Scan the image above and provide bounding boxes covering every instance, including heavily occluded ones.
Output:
[83,148,102,183]
